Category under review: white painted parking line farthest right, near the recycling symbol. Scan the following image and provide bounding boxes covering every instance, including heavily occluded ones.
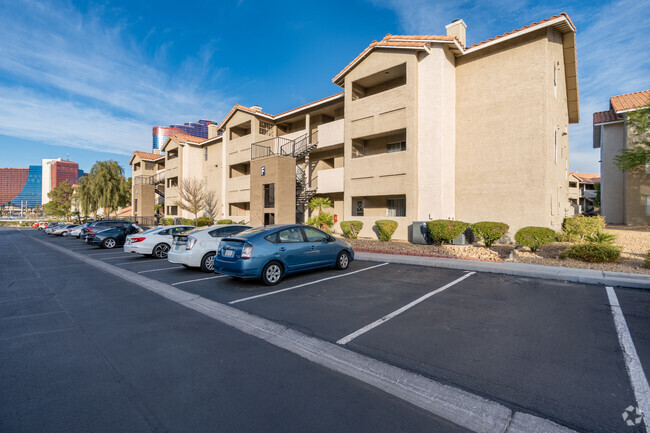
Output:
[607,287,650,433]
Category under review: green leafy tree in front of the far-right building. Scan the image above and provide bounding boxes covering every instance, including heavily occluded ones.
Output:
[614,100,650,171]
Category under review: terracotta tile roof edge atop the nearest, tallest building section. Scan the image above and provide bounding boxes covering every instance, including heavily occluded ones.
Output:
[332,12,576,85]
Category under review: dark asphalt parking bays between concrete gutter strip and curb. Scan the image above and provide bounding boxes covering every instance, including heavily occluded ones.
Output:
[3,231,650,432]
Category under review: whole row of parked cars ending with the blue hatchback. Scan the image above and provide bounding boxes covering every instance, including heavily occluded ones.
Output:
[36,220,354,285]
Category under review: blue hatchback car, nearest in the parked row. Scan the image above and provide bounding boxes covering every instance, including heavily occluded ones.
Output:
[214,224,354,286]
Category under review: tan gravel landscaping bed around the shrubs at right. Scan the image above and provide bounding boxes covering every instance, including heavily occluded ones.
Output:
[346,226,650,274]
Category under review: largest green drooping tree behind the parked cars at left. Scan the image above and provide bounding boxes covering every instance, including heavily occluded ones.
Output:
[89,160,131,216]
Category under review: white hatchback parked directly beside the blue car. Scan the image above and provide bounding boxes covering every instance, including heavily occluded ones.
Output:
[167,224,251,272]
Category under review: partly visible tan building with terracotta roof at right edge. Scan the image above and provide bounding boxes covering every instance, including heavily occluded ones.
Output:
[593,90,650,225]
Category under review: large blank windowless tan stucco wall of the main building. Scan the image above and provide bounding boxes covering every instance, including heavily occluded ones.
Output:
[455,30,568,233]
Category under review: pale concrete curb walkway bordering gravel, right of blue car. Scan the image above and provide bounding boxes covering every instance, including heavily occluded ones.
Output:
[354,252,650,290]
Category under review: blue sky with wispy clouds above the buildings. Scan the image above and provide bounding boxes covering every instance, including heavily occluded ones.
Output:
[0,0,650,173]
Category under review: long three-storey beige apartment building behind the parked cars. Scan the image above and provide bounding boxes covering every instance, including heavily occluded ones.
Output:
[130,14,579,239]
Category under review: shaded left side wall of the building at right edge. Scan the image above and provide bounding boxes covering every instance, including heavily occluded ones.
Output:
[600,123,626,224]
